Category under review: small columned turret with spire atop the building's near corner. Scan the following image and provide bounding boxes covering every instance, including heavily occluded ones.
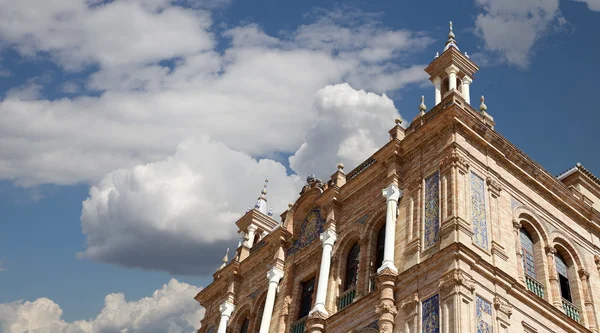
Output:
[425,21,479,105]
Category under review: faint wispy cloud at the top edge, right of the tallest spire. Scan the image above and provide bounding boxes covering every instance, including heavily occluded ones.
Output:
[475,0,564,68]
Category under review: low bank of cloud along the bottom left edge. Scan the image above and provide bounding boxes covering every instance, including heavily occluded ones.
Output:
[0,279,204,333]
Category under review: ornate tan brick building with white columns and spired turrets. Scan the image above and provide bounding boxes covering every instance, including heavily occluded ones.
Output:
[196,22,600,333]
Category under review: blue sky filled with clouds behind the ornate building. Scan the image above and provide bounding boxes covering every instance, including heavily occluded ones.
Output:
[0,0,600,332]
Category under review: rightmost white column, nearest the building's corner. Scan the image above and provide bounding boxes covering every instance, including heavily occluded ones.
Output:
[377,184,402,273]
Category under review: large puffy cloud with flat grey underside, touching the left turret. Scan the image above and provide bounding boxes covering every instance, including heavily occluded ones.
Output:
[79,137,302,274]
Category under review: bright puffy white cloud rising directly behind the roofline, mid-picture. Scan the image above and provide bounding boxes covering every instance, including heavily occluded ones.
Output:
[289,84,399,179]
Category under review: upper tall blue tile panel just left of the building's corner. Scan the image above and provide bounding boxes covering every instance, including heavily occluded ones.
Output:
[423,171,440,248]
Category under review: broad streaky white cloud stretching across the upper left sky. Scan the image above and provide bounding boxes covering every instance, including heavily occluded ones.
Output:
[0,0,431,186]
